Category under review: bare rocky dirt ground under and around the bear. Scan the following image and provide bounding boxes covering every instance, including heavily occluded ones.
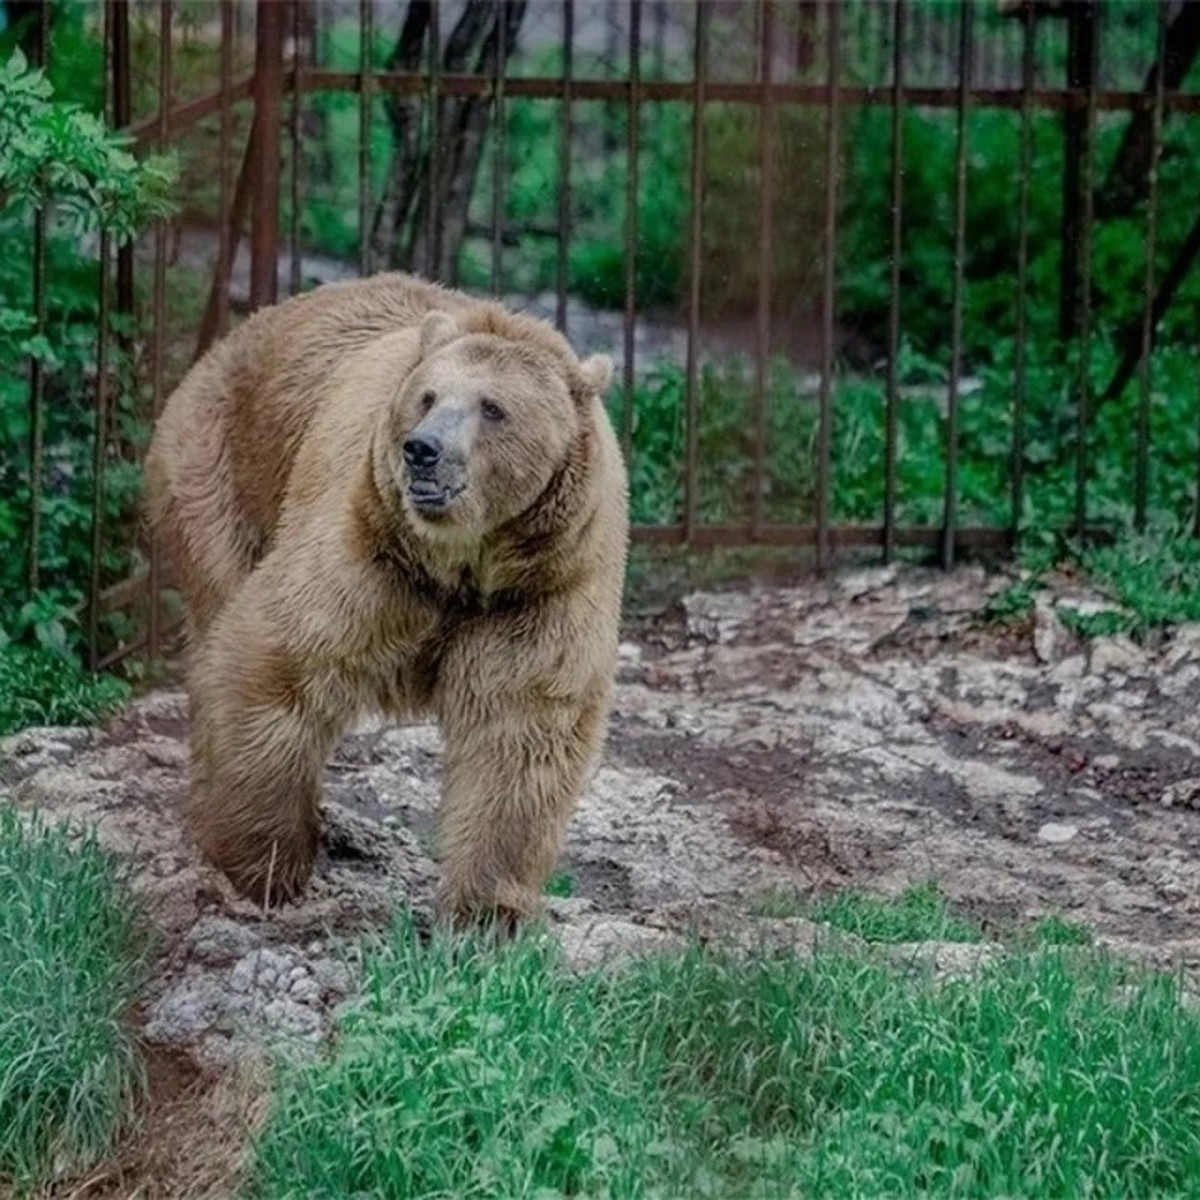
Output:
[7,569,1200,1196]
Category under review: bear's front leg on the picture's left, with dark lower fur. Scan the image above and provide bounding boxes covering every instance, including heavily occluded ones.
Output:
[188,578,341,904]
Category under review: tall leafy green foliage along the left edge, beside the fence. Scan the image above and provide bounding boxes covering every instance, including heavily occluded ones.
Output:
[0,46,175,724]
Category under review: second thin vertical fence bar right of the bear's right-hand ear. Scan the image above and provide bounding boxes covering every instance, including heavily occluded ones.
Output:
[683,0,708,542]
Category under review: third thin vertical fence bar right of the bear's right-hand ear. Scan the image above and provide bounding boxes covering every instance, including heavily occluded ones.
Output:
[750,0,775,541]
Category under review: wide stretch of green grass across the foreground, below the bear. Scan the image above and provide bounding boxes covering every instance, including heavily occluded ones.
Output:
[247,919,1200,1200]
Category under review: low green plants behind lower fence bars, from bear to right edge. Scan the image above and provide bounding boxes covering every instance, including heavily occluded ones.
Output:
[611,340,1196,542]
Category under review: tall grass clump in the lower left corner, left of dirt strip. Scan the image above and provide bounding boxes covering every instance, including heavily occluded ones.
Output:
[0,803,144,1190]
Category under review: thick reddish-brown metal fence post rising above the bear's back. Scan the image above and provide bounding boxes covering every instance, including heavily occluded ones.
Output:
[250,0,284,308]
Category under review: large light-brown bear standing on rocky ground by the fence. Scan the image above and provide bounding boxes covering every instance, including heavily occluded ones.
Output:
[146,274,629,919]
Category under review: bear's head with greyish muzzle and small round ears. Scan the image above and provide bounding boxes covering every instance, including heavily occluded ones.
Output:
[386,304,612,538]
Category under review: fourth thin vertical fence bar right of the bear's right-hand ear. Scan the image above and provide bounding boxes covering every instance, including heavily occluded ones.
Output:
[816,4,841,571]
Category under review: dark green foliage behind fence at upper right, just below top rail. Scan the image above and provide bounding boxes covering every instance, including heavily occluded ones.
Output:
[838,99,1200,362]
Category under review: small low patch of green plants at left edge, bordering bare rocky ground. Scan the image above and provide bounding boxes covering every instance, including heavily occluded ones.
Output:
[0,644,130,734]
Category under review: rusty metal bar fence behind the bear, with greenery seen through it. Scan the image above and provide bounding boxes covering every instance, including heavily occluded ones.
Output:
[11,0,1200,666]
